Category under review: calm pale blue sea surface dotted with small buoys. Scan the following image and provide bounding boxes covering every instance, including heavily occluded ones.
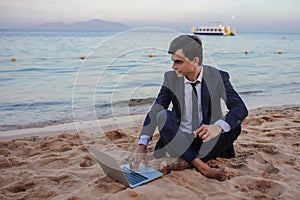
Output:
[0,28,300,131]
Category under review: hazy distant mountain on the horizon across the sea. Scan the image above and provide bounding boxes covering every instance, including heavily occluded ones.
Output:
[28,19,129,31]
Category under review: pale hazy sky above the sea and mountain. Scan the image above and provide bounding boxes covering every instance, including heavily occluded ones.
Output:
[0,0,300,33]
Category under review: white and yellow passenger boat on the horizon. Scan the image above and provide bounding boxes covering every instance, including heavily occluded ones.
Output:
[191,24,235,36]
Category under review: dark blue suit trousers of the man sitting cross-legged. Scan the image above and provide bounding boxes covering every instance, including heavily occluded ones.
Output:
[153,110,241,163]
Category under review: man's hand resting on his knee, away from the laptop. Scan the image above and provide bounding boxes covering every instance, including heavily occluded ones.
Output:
[194,124,222,142]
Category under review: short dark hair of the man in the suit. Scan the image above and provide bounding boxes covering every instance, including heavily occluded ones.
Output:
[168,35,203,65]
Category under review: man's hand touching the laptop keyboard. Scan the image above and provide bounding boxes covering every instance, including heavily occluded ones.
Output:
[129,144,148,171]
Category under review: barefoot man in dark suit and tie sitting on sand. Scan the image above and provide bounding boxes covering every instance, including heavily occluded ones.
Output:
[130,35,248,180]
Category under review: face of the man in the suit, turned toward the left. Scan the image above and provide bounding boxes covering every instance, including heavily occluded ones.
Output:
[171,49,195,77]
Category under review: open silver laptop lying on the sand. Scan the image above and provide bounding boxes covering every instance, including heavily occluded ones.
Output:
[88,147,163,188]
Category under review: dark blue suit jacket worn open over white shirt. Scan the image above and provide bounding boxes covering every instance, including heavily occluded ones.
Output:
[141,66,248,137]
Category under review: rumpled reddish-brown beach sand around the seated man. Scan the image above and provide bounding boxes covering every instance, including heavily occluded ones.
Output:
[0,105,300,200]
